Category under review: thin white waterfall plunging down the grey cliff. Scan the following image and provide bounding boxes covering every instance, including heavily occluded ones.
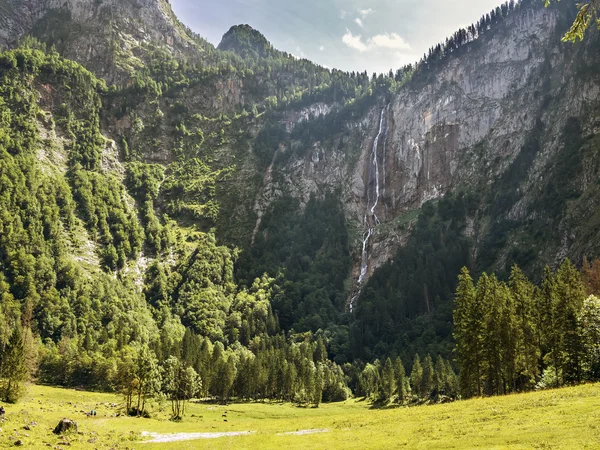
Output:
[349,105,389,312]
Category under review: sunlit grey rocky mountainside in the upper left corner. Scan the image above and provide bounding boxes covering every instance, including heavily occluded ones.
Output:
[0,0,199,82]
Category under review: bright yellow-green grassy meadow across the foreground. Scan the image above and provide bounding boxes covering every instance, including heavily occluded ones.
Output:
[0,384,600,450]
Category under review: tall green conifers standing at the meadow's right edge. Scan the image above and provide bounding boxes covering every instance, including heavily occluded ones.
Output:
[454,259,600,398]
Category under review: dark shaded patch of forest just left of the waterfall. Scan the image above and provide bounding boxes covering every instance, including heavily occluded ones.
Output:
[237,194,351,331]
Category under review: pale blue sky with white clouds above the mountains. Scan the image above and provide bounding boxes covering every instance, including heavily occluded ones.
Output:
[171,0,502,73]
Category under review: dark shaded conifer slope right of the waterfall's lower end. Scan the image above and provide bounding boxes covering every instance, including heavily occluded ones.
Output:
[350,195,475,360]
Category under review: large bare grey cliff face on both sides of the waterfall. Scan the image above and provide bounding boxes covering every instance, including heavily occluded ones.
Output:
[247,4,600,279]
